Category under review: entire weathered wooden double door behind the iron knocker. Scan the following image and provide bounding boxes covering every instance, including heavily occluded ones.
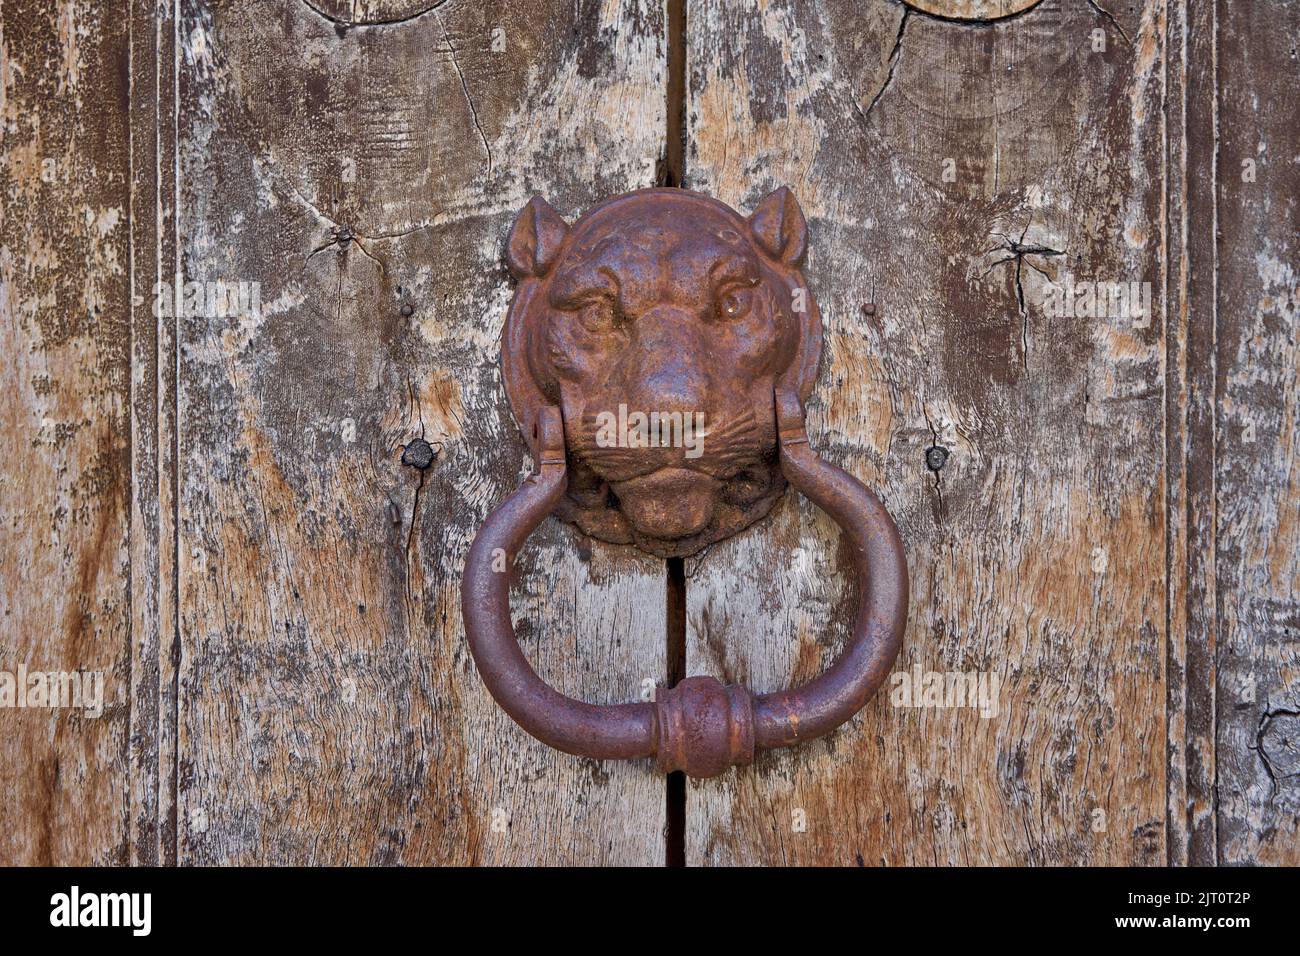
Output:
[0,0,1300,865]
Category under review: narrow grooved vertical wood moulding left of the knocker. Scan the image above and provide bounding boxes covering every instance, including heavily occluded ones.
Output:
[127,0,178,866]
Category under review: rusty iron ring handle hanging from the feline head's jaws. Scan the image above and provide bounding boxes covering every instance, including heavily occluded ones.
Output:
[460,392,907,777]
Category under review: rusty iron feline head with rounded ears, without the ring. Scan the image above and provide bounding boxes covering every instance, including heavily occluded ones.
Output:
[502,187,822,557]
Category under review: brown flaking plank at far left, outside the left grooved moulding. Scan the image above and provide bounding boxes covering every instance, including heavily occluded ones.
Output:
[0,0,131,865]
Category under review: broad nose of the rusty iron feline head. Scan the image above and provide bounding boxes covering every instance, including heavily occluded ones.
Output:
[624,306,709,412]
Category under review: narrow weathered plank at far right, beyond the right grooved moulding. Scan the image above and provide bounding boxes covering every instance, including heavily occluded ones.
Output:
[1216,0,1300,866]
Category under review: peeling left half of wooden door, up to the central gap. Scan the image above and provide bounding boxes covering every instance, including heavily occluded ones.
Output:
[0,3,667,864]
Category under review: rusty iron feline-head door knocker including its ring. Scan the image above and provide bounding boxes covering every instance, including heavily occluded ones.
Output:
[462,187,907,777]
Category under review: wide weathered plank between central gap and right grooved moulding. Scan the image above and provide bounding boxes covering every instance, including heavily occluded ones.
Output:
[686,0,1166,864]
